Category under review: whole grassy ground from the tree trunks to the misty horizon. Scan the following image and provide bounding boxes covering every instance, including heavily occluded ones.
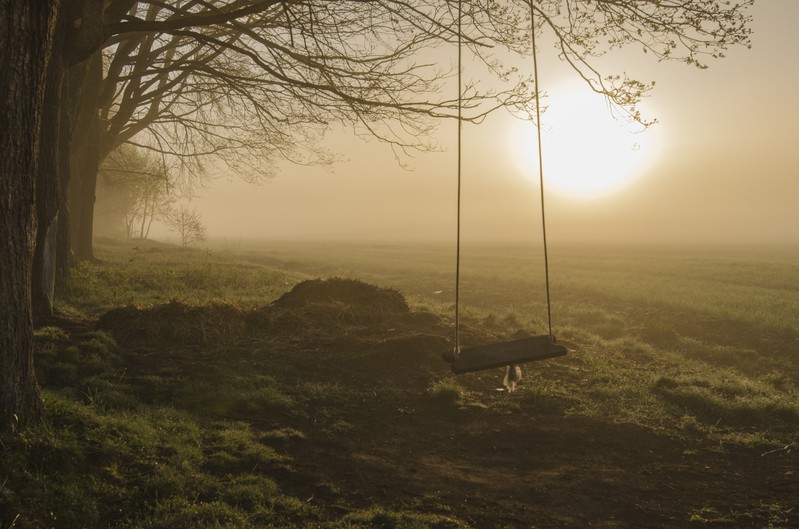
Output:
[0,237,799,529]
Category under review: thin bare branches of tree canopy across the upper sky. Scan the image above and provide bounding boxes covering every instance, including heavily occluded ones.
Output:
[95,0,751,184]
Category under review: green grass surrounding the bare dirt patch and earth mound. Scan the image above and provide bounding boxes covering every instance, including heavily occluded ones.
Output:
[0,242,799,529]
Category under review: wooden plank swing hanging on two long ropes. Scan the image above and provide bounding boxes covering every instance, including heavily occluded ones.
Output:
[444,0,566,374]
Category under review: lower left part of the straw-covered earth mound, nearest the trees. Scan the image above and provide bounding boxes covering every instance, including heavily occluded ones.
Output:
[97,301,247,345]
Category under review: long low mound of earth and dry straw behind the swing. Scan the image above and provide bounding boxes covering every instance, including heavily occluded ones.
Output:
[97,278,446,345]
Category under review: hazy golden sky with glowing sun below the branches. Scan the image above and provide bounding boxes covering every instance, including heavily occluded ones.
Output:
[183,0,799,244]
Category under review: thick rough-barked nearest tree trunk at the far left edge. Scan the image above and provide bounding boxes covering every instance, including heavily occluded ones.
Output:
[0,0,60,428]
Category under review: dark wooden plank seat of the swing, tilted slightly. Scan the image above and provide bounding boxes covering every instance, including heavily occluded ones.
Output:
[444,335,566,375]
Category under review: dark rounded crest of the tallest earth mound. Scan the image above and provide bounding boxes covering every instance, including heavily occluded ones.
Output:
[272,277,410,315]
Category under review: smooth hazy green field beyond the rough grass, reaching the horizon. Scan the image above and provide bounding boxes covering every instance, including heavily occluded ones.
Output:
[234,243,799,361]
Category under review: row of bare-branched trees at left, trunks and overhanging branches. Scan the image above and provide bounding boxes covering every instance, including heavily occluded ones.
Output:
[0,0,752,427]
